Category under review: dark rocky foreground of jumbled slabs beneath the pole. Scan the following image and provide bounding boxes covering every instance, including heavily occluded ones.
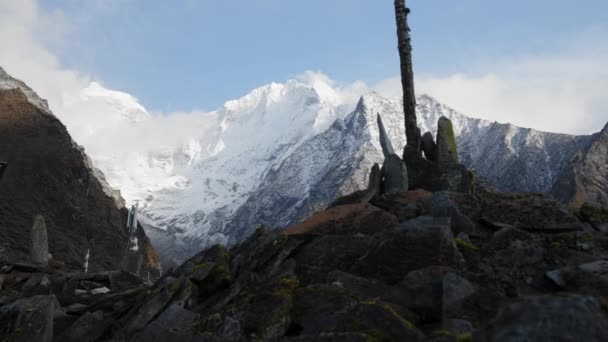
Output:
[0,191,608,342]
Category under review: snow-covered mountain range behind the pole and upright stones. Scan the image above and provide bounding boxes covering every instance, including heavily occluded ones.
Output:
[0,66,605,259]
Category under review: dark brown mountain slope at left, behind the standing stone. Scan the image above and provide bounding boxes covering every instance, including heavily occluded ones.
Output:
[0,75,159,276]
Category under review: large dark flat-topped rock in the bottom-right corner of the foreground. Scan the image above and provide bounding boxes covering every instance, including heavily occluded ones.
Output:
[474,295,608,342]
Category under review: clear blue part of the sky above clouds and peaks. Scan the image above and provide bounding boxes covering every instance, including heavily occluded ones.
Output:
[41,0,608,111]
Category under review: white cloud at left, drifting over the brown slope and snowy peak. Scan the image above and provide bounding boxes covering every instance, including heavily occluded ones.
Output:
[0,0,215,163]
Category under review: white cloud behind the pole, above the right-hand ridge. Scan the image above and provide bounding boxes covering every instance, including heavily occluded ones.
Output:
[375,29,608,134]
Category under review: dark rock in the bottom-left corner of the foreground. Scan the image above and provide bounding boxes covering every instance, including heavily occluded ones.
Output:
[0,295,60,342]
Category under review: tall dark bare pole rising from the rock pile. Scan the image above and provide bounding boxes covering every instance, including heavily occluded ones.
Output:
[395,0,421,157]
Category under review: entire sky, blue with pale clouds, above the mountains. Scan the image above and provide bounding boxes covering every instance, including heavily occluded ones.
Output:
[0,0,608,133]
